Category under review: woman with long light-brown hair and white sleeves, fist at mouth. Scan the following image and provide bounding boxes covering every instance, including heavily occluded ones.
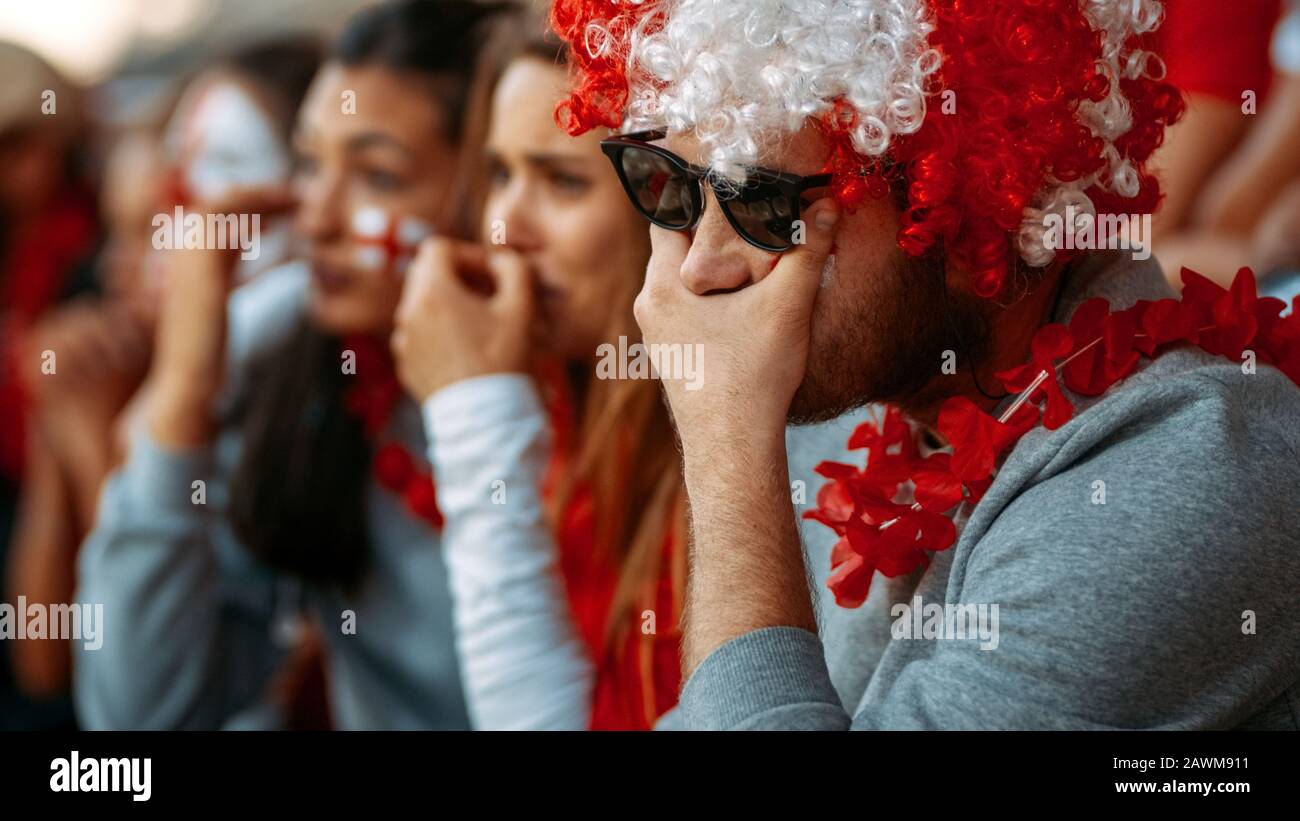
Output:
[394,16,685,730]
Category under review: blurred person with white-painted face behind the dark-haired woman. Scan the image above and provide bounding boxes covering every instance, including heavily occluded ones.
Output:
[8,36,320,717]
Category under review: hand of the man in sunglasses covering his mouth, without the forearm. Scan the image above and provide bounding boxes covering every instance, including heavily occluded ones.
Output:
[634,197,840,455]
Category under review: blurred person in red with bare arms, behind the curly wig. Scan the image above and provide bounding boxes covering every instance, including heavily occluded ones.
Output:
[1154,0,1300,299]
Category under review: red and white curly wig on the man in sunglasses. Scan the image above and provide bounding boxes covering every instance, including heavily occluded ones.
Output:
[551,0,1183,296]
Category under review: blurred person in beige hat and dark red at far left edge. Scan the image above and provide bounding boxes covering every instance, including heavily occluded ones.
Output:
[0,43,99,727]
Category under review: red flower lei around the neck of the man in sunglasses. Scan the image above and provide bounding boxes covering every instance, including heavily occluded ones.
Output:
[803,268,1300,608]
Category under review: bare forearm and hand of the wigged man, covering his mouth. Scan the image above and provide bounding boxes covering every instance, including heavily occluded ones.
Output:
[636,200,840,676]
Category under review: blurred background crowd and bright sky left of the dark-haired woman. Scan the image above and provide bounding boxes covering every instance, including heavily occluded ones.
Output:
[0,0,377,729]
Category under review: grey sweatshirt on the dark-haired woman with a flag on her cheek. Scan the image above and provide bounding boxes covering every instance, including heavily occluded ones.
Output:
[73,266,469,729]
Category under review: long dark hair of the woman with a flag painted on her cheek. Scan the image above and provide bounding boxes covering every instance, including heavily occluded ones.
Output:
[230,0,512,591]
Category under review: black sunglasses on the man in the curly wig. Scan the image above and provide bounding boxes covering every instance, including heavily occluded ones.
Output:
[601,130,831,252]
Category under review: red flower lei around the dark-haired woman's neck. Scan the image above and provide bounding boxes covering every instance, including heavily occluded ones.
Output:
[343,336,442,530]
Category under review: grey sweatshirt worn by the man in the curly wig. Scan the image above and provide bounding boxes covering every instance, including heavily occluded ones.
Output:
[662,255,1300,730]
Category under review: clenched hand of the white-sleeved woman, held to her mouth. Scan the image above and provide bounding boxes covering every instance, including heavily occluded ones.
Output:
[393,238,534,403]
